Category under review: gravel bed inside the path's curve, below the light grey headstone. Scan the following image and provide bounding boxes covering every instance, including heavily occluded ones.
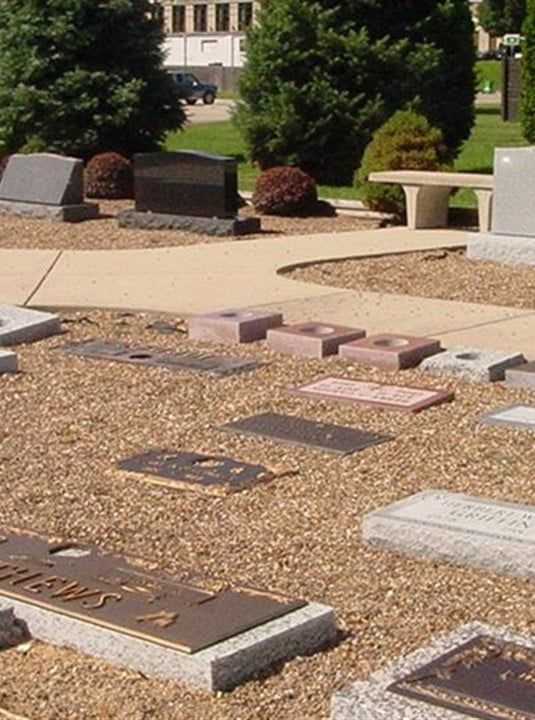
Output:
[288,250,535,309]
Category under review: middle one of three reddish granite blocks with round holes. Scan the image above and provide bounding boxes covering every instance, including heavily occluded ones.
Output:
[267,322,366,358]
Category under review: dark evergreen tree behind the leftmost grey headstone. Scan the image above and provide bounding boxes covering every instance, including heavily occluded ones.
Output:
[0,0,184,157]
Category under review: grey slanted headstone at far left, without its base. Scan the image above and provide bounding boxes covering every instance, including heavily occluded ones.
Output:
[0,153,84,205]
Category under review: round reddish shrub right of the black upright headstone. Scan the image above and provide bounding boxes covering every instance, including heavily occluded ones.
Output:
[253,167,318,216]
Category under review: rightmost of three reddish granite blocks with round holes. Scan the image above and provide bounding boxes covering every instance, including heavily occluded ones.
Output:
[338,334,442,370]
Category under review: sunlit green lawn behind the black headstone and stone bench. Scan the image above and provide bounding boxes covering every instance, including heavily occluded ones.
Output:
[166,107,528,207]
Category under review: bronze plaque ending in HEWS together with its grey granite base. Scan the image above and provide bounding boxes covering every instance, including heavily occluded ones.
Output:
[0,528,337,691]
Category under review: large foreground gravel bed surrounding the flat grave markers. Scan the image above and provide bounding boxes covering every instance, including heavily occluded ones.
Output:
[0,312,535,720]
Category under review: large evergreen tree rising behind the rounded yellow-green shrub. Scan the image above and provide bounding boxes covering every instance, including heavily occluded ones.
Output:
[236,0,475,183]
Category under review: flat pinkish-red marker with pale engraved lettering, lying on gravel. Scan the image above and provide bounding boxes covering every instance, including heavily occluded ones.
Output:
[289,377,454,412]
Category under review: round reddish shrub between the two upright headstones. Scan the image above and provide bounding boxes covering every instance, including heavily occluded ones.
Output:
[85,152,134,200]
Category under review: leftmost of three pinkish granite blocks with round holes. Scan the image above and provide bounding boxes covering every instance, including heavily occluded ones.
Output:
[188,308,282,343]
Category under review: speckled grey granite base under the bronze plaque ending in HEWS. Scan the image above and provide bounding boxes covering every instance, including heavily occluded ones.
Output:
[0,595,337,691]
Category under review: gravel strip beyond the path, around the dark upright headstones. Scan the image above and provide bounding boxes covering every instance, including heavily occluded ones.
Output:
[0,200,379,250]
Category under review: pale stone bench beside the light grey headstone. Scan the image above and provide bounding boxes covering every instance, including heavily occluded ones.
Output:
[368,170,494,232]
